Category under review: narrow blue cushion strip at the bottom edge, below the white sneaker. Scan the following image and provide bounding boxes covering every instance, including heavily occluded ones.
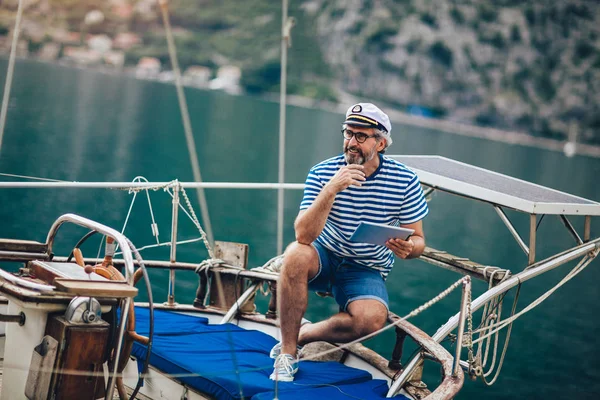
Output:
[252,379,409,400]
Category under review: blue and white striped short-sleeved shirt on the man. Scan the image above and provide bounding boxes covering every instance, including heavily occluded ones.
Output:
[300,154,429,279]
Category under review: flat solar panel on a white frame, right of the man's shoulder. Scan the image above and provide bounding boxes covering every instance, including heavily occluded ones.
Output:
[390,156,600,215]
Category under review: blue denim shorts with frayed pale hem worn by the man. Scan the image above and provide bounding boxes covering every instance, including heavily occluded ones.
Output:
[308,242,389,311]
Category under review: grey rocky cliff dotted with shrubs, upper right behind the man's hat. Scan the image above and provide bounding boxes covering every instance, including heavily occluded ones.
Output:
[305,0,600,143]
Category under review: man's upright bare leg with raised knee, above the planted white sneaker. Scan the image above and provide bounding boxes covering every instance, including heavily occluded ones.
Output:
[277,242,319,356]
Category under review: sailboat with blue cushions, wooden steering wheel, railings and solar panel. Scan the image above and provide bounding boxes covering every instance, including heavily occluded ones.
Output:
[0,0,600,399]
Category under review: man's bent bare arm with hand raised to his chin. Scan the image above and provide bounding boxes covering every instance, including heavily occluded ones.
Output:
[294,164,366,244]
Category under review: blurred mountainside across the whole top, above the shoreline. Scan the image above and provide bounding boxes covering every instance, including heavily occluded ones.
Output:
[0,0,600,144]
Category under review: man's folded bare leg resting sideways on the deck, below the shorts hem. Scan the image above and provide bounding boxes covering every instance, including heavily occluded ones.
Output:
[298,299,388,345]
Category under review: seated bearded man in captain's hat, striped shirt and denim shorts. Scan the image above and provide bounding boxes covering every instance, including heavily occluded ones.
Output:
[271,103,428,382]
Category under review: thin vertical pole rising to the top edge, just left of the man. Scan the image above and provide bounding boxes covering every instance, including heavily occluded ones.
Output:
[277,0,289,254]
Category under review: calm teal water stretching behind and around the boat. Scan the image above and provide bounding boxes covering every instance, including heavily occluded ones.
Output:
[0,57,600,399]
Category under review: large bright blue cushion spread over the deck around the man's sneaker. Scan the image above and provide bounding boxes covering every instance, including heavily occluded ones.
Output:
[132,307,406,400]
